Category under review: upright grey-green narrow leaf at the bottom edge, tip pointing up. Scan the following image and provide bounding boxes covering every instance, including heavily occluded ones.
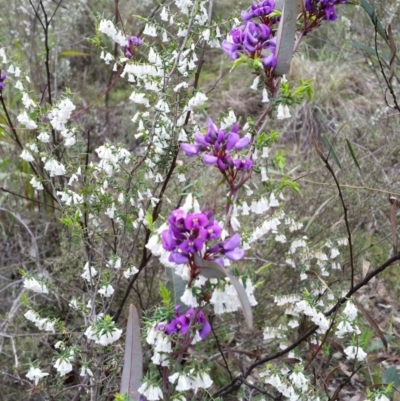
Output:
[120,304,143,401]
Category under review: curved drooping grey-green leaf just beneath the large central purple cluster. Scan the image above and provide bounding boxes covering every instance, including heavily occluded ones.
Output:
[194,254,253,329]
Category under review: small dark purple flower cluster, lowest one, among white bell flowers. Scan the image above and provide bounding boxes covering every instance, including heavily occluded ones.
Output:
[156,305,211,340]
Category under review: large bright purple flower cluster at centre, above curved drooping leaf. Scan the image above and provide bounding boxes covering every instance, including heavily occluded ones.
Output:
[161,209,244,266]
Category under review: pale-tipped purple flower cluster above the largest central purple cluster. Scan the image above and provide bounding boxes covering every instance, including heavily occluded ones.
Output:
[181,118,253,171]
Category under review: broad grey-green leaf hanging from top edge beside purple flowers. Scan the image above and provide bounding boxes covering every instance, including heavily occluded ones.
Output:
[274,0,298,75]
